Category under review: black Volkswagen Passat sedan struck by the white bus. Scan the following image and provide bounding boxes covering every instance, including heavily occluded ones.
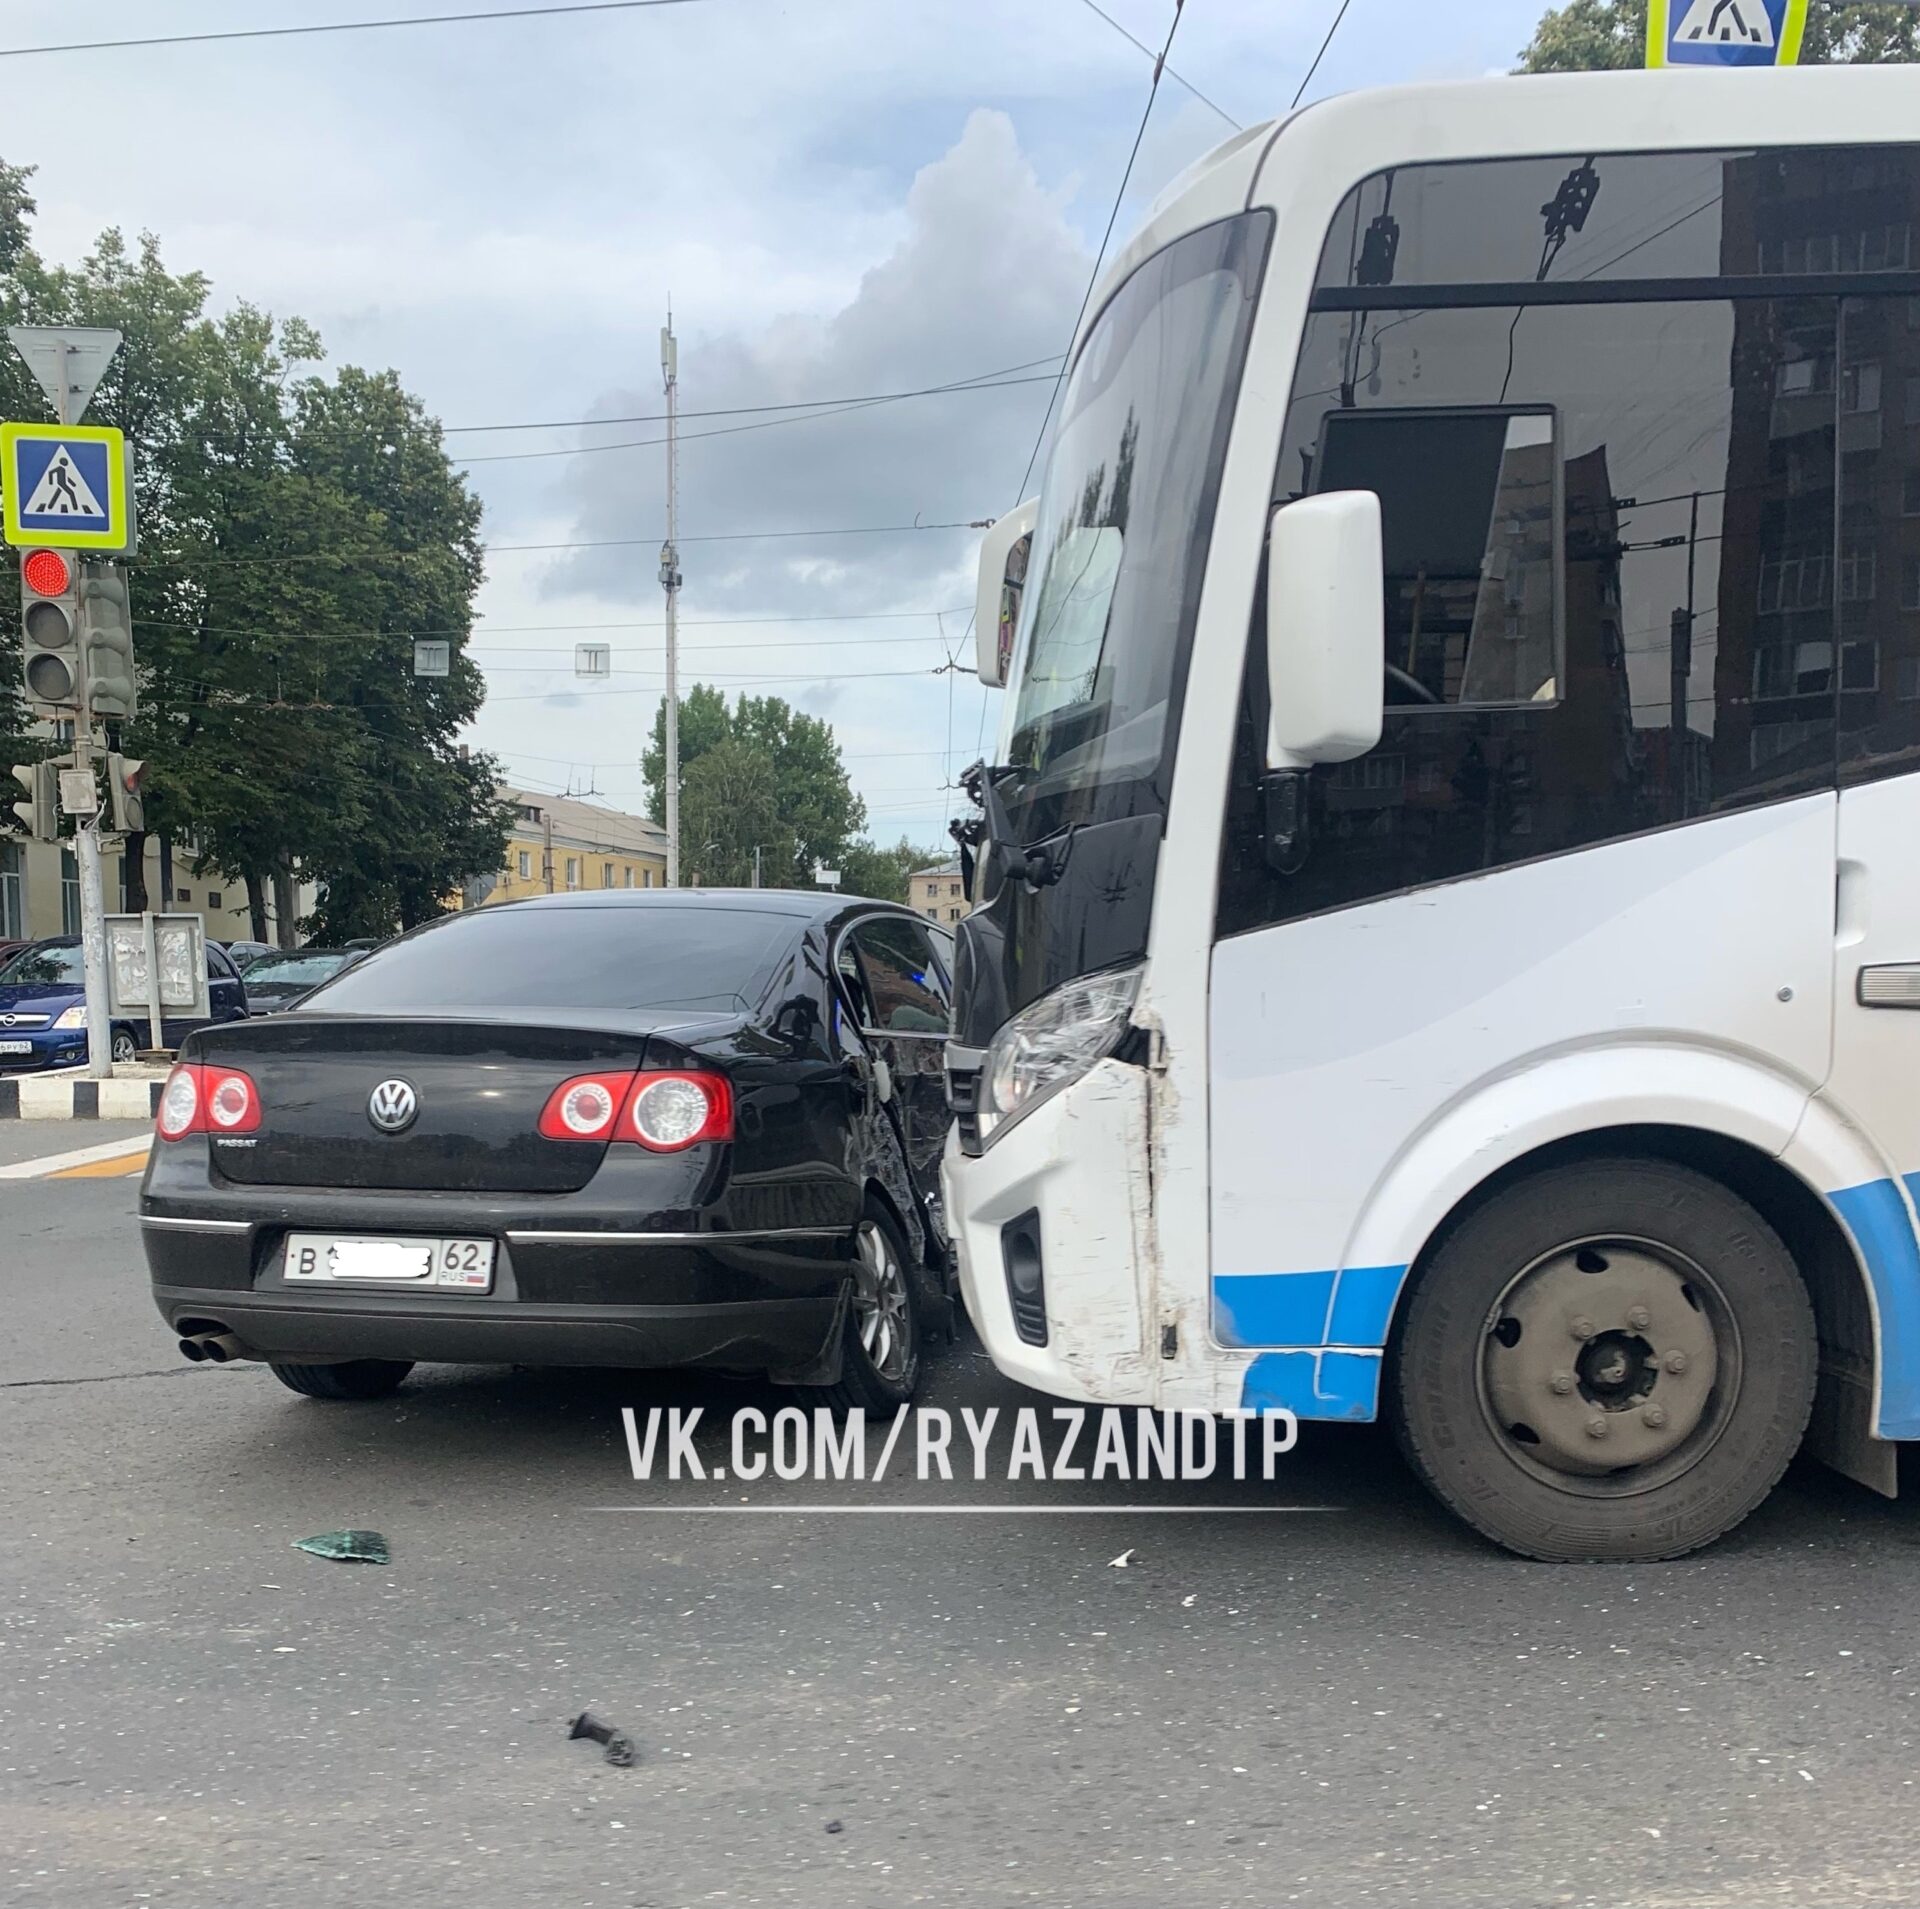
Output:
[140,889,952,1410]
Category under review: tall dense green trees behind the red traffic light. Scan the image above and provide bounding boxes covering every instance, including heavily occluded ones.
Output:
[0,165,507,937]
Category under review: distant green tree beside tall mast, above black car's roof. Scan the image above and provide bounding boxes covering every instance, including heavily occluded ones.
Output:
[641,684,866,887]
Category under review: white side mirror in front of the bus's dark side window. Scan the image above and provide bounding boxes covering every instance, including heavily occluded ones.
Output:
[1267,490,1386,774]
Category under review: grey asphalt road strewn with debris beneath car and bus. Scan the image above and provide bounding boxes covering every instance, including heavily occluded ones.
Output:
[11,1179,1920,1909]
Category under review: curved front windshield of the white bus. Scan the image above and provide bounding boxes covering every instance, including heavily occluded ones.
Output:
[1000,213,1267,841]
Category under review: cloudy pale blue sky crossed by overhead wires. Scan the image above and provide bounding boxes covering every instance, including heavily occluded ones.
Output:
[0,0,1542,843]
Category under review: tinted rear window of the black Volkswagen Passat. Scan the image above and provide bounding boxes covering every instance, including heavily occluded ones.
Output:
[296,906,797,1014]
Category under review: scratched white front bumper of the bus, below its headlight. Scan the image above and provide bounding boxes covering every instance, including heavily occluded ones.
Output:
[941,1060,1158,1406]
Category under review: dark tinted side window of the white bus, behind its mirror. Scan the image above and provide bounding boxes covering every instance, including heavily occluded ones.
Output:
[1219,146,1920,933]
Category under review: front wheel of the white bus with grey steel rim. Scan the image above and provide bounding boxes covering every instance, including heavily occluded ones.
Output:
[1390,1160,1814,1559]
